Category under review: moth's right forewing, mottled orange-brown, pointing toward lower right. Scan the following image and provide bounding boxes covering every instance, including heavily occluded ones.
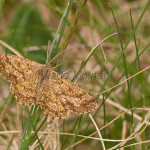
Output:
[40,69,97,114]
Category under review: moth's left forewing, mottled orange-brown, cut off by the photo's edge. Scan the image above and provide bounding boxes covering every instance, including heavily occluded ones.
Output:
[0,53,42,84]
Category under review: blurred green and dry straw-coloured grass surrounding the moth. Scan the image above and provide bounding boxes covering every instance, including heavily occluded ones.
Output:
[0,0,150,150]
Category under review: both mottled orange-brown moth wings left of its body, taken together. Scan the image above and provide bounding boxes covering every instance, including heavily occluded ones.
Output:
[0,53,42,105]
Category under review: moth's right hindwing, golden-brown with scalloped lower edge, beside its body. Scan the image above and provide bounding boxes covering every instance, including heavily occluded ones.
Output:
[37,71,68,119]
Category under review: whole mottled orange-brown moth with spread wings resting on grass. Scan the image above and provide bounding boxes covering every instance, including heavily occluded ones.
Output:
[0,53,97,119]
